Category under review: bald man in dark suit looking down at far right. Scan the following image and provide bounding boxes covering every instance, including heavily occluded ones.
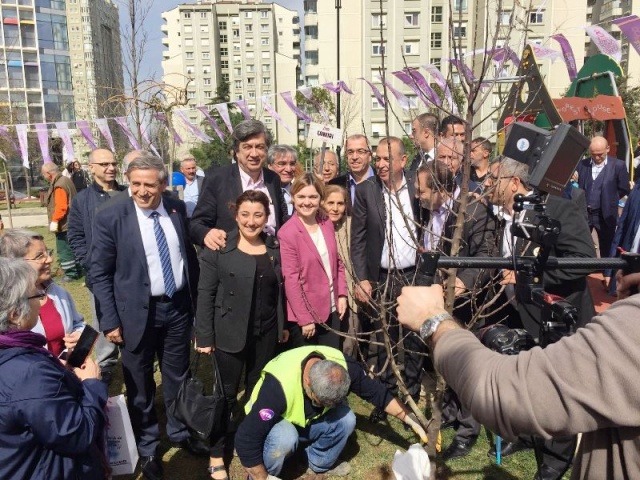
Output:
[577,136,630,258]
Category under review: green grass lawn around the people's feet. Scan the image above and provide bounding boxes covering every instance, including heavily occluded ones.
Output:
[34,228,569,480]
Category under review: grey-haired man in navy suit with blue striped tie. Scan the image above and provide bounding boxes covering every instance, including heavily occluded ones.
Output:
[90,154,208,480]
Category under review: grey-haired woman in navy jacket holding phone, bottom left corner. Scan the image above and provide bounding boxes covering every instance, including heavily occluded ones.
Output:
[0,258,107,480]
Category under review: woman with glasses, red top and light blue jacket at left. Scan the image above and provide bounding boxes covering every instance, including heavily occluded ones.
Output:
[0,229,85,356]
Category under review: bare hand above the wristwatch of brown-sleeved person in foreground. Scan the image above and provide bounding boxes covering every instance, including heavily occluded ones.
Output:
[397,285,446,332]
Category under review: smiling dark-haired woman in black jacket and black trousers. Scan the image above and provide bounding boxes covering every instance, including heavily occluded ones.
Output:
[196,190,289,479]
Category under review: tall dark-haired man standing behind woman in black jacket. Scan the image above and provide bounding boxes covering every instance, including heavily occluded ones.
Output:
[189,120,287,250]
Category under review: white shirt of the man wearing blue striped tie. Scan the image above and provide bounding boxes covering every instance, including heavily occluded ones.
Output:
[133,202,185,297]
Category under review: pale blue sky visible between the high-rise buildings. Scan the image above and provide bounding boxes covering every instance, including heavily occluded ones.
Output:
[113,0,303,80]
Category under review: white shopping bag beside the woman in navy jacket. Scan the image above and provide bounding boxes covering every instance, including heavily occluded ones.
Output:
[107,395,138,476]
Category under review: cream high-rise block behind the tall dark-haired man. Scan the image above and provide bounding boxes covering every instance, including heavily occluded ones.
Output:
[162,0,300,155]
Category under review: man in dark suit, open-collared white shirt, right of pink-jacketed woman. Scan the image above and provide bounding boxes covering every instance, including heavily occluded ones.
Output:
[351,137,424,416]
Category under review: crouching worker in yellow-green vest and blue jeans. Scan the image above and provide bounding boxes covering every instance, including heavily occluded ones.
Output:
[235,345,427,480]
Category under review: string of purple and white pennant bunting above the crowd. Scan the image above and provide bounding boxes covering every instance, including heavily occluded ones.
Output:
[0,22,640,168]
